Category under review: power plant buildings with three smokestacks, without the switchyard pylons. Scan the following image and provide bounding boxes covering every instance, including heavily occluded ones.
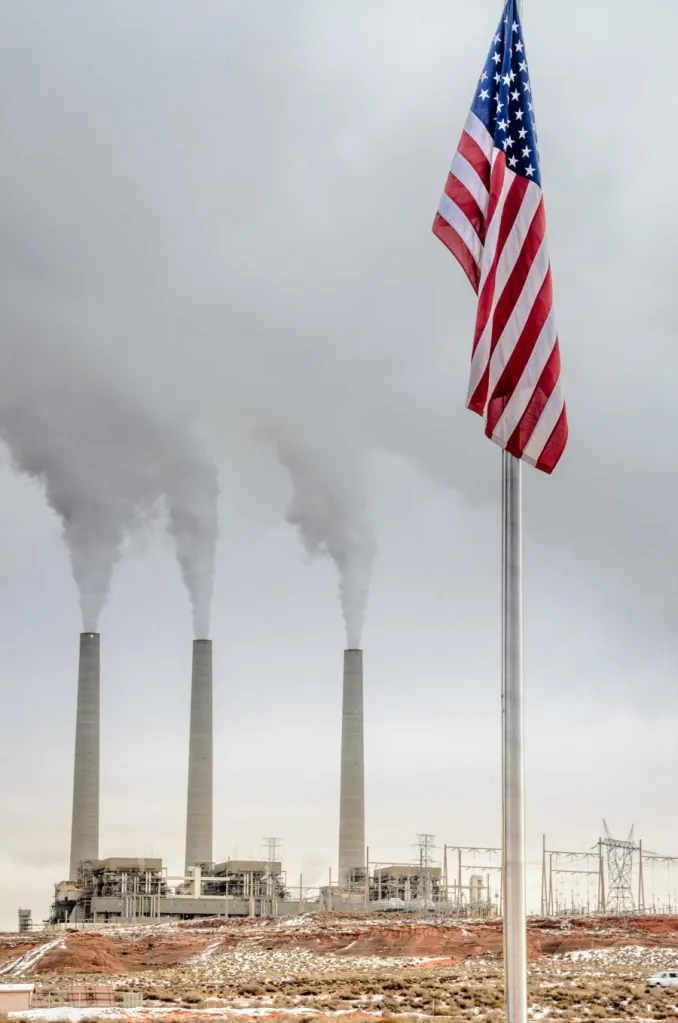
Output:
[46,632,503,929]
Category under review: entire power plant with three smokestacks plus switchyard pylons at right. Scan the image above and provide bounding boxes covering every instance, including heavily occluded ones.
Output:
[35,632,678,930]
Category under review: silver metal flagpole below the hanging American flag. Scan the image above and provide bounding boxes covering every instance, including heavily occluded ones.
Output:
[501,451,528,1023]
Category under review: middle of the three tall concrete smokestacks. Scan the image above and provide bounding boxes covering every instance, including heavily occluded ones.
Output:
[186,639,213,871]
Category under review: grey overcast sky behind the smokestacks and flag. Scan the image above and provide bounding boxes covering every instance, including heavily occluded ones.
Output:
[0,0,678,927]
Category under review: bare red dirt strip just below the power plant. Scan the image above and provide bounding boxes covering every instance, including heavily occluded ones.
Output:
[10,914,678,976]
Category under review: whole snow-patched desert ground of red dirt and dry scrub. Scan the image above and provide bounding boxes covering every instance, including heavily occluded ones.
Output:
[0,914,678,1023]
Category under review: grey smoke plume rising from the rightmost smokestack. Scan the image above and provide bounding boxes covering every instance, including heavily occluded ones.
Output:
[277,433,376,649]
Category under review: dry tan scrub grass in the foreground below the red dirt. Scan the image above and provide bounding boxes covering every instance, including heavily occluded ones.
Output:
[18,949,678,1023]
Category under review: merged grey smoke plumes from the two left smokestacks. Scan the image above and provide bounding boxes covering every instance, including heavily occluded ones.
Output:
[0,351,218,636]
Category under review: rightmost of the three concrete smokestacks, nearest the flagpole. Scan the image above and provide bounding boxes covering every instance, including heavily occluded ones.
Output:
[338,650,365,884]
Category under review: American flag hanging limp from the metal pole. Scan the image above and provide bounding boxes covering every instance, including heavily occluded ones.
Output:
[434,0,568,473]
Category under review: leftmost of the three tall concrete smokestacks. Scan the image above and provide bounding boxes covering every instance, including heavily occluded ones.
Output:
[69,632,99,881]
